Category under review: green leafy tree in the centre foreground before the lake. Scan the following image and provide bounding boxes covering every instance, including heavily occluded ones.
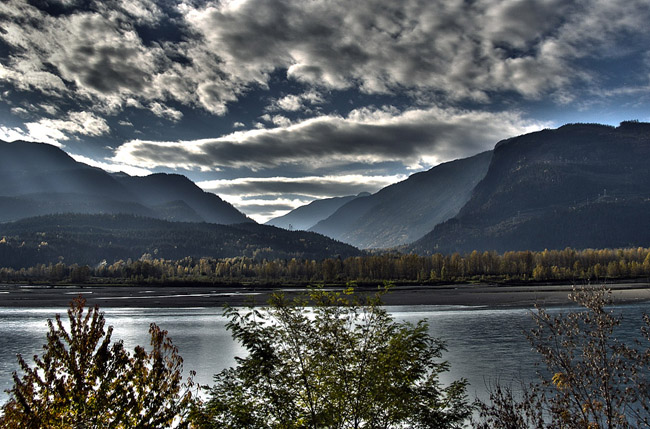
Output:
[195,289,472,428]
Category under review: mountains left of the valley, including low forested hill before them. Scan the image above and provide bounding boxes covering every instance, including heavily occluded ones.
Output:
[0,141,361,268]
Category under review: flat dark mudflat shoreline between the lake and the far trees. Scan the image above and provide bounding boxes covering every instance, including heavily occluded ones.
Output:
[0,282,650,311]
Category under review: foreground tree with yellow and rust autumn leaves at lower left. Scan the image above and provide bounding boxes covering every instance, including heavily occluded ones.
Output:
[0,298,192,428]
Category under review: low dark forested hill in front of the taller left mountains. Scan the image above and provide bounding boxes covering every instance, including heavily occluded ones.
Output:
[0,214,361,268]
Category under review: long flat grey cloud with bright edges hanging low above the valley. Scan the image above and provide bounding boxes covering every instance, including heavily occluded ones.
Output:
[114,108,542,170]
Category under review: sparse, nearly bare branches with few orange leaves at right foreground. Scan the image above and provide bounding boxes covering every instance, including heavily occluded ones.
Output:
[477,288,650,429]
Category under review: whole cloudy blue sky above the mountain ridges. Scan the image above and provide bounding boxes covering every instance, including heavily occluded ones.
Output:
[0,0,650,222]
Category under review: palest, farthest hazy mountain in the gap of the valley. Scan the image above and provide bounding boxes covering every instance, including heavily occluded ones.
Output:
[266,192,370,231]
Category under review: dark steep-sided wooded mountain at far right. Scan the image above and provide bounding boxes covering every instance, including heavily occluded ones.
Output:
[410,122,650,253]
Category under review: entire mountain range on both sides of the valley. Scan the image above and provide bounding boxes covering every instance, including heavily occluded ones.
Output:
[0,121,650,265]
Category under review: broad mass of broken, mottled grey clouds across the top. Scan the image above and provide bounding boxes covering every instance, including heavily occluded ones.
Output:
[0,0,650,122]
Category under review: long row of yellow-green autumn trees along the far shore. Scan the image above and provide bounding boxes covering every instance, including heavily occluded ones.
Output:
[0,247,650,285]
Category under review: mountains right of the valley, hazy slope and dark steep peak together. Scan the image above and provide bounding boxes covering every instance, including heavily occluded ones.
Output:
[270,121,650,254]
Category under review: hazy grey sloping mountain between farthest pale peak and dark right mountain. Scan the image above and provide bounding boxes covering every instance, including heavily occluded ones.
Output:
[310,151,492,248]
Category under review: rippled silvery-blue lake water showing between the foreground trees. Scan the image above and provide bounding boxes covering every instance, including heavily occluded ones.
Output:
[0,304,648,403]
